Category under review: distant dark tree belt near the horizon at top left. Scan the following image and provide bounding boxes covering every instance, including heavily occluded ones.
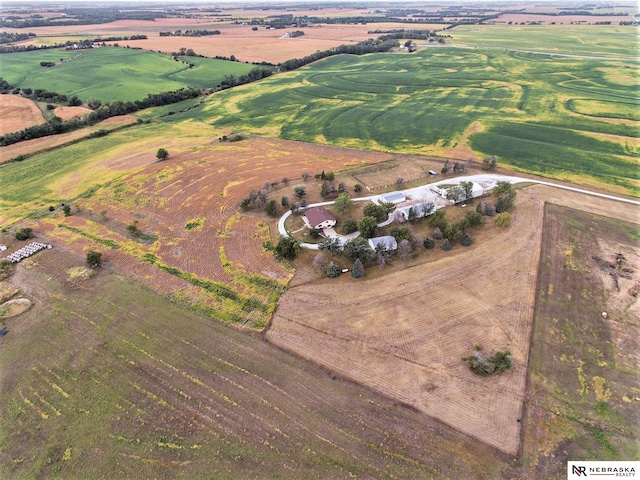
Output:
[0,7,166,28]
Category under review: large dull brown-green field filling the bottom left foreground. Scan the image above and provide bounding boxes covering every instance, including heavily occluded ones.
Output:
[0,249,510,479]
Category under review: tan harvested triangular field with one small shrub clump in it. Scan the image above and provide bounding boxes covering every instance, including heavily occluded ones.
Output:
[267,186,636,454]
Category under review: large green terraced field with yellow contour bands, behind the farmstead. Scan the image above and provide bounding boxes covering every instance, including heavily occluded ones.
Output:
[181,39,640,196]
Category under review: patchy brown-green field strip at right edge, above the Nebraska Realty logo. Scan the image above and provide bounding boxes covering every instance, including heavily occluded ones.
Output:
[522,204,640,478]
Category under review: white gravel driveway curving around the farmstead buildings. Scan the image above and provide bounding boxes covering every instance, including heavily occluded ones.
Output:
[278,173,640,250]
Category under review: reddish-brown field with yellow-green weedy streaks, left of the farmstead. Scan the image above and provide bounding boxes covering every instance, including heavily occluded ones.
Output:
[37,136,388,328]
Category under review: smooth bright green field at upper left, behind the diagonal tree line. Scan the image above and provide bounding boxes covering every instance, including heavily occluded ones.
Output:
[0,47,254,102]
